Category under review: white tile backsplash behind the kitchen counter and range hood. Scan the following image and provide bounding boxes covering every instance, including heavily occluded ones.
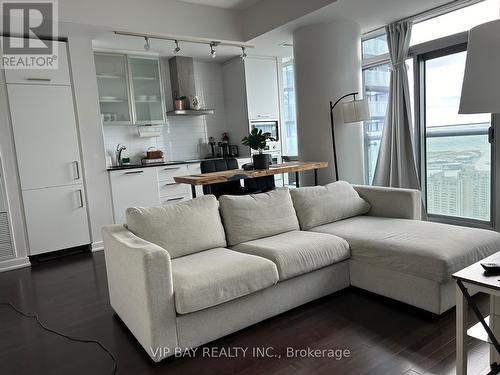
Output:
[103,61,231,163]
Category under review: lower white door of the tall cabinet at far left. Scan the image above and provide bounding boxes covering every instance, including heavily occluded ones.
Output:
[23,184,90,255]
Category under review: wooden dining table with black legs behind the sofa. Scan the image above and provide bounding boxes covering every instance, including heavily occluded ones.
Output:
[174,161,328,198]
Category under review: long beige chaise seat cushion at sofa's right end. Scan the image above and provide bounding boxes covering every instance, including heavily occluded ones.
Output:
[312,216,500,283]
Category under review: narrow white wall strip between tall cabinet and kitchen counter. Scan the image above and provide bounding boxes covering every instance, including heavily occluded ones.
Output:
[68,36,113,249]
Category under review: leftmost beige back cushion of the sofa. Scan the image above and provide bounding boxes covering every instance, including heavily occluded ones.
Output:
[127,195,226,258]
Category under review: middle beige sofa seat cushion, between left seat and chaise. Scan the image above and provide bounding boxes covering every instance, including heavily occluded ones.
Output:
[232,231,349,281]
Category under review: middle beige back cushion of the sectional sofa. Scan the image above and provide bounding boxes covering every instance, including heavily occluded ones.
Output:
[219,188,299,246]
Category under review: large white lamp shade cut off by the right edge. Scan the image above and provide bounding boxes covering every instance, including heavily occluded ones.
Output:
[458,20,500,114]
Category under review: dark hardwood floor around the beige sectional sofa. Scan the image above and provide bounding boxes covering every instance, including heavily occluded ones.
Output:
[0,252,489,375]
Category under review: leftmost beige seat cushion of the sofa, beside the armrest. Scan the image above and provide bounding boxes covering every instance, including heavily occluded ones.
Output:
[172,248,278,314]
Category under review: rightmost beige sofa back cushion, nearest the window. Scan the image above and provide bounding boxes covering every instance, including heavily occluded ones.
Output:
[290,181,370,230]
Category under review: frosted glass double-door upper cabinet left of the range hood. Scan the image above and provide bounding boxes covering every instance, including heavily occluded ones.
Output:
[95,53,165,125]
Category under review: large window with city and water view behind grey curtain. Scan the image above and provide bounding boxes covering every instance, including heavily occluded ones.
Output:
[362,0,500,222]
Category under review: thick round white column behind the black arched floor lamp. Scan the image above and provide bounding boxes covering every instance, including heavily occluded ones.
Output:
[293,20,363,184]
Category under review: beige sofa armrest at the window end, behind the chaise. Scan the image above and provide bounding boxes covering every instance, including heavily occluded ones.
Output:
[353,185,422,220]
